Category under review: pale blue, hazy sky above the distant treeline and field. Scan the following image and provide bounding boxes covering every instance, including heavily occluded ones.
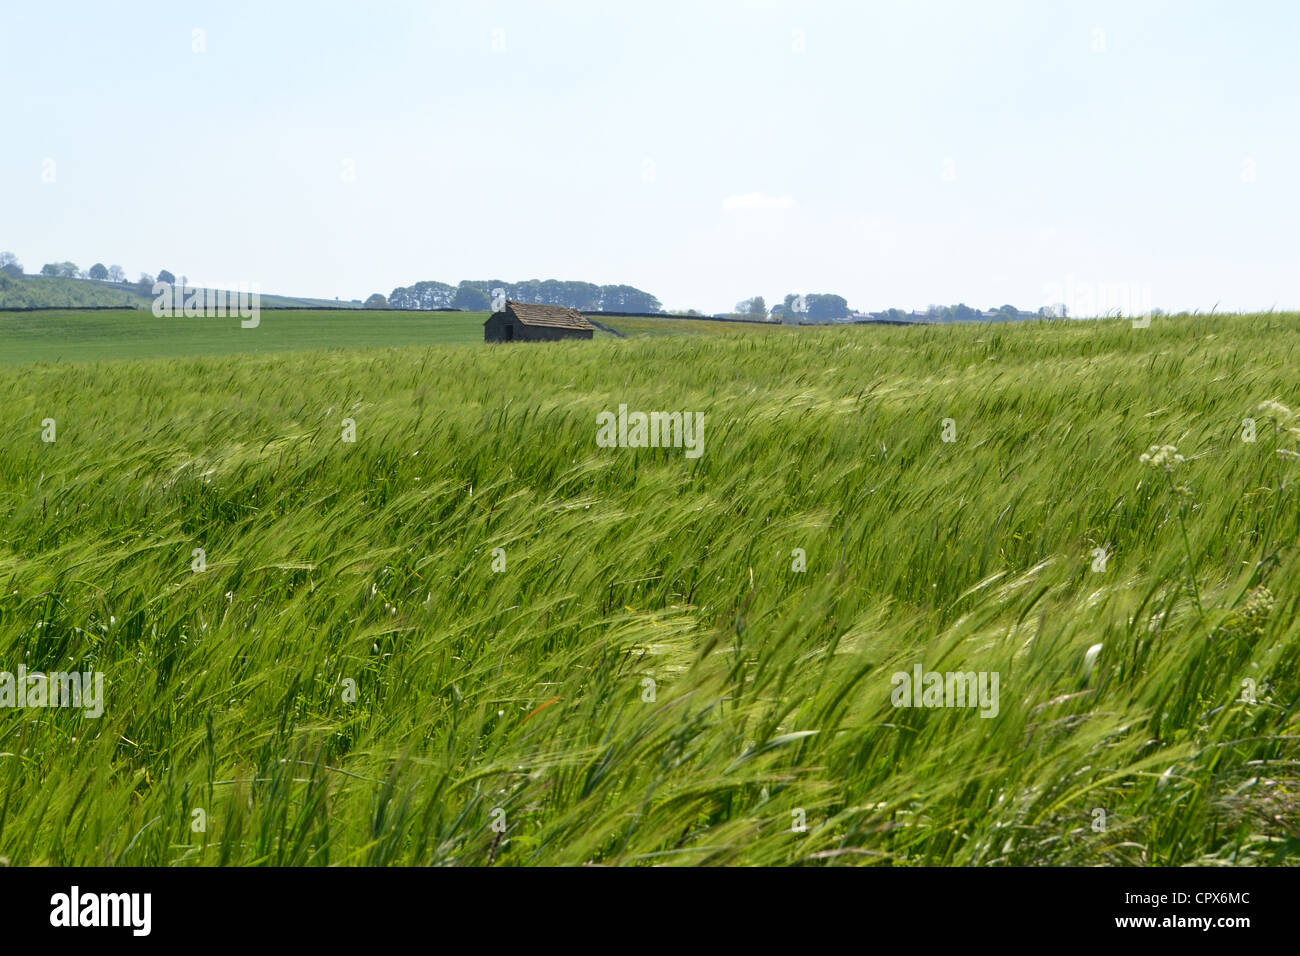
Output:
[0,0,1300,311]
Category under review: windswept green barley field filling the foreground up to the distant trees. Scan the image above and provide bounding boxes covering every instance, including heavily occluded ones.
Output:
[0,312,1300,866]
